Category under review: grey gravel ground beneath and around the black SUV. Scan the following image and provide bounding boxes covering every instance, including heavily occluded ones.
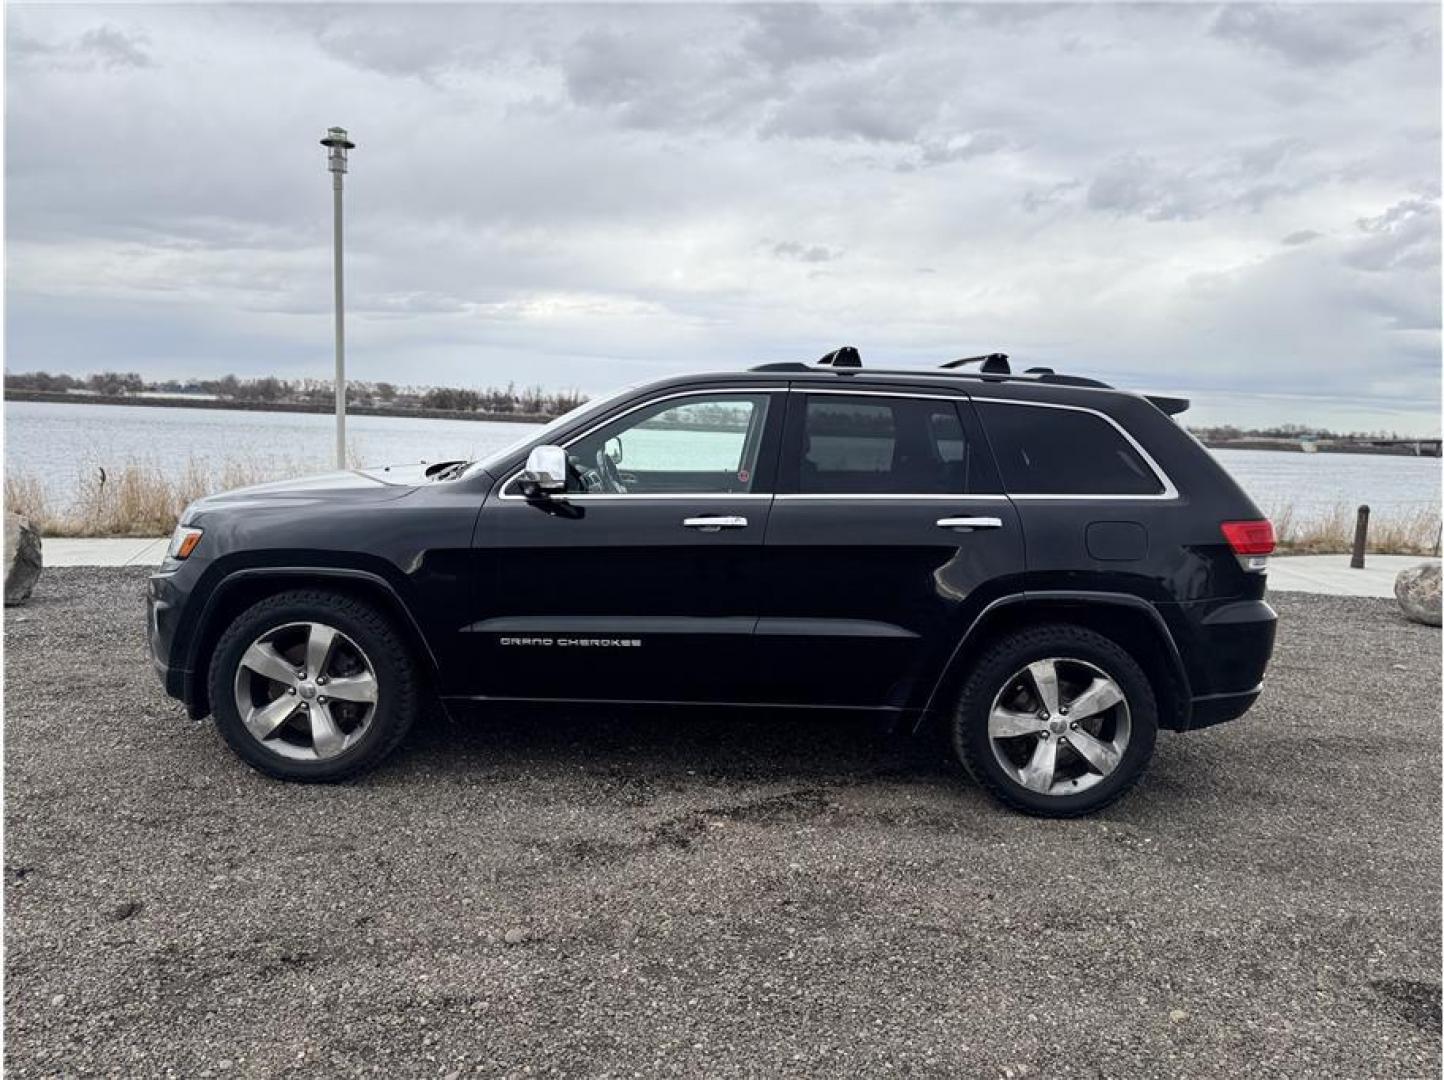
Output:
[4,570,1441,1077]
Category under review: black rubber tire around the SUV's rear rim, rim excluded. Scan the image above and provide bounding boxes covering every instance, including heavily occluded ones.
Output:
[953,622,1158,817]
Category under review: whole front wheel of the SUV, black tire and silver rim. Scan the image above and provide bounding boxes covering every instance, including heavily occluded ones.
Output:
[209,589,419,783]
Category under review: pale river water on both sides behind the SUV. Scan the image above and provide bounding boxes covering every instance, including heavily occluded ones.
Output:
[4,401,1440,520]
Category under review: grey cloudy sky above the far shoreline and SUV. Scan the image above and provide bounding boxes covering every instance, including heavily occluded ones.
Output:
[6,4,1440,432]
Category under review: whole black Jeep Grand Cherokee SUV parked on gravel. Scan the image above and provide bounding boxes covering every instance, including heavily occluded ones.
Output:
[149,348,1275,816]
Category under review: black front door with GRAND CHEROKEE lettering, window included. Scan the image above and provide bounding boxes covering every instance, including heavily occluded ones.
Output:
[466,388,786,702]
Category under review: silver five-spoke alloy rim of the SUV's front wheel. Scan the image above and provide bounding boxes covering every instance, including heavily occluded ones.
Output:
[235,622,377,761]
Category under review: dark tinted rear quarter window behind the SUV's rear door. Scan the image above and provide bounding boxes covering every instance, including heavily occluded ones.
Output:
[976,401,1164,495]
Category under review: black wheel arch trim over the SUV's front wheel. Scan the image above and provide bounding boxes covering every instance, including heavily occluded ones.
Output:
[185,566,439,718]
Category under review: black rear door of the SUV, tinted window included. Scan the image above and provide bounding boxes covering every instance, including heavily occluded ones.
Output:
[757,388,1024,709]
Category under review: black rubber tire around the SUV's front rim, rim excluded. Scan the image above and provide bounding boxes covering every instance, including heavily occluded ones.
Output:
[209,589,420,784]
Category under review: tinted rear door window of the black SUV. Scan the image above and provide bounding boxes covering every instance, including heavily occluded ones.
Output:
[790,394,973,495]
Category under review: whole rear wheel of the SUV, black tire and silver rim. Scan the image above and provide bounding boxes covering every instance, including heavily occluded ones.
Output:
[953,624,1158,817]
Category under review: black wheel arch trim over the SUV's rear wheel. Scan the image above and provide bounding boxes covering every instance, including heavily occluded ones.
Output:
[917,591,1193,731]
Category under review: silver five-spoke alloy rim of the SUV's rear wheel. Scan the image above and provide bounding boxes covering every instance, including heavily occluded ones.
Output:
[988,657,1132,796]
